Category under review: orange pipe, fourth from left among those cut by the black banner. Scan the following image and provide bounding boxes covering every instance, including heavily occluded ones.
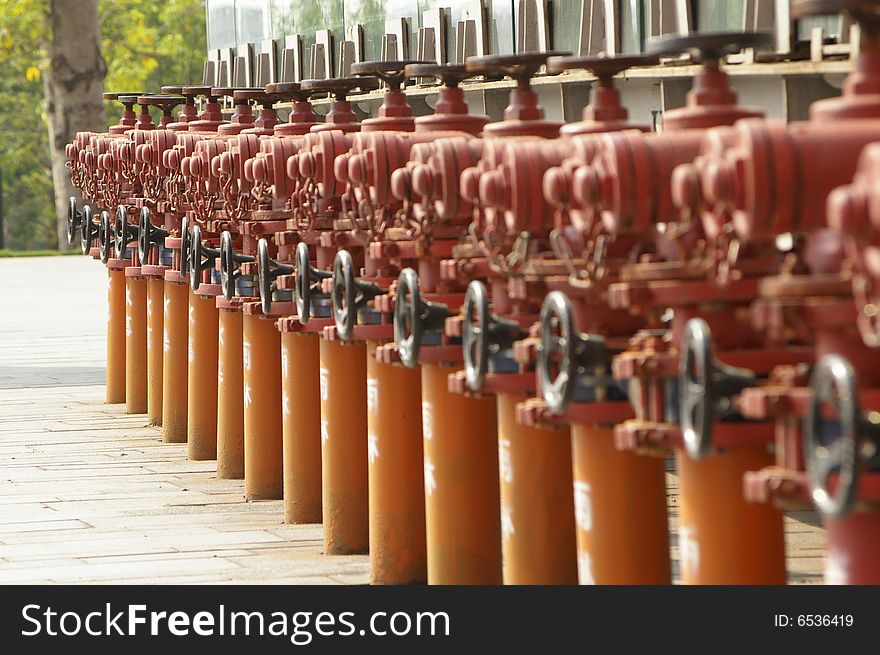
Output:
[571,423,672,585]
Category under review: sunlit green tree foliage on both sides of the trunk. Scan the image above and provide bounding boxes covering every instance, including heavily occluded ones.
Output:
[0,0,206,250]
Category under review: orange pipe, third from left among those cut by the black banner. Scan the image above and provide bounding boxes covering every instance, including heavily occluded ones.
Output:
[498,392,578,584]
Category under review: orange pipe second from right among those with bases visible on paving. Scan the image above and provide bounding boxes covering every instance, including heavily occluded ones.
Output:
[281,330,321,523]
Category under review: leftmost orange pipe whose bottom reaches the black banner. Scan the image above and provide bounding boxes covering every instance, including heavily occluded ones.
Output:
[367,342,428,584]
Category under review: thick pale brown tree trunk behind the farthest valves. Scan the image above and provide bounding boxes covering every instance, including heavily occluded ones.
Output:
[43,0,107,250]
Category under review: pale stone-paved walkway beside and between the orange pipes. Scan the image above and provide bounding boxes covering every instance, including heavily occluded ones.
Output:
[0,256,824,584]
